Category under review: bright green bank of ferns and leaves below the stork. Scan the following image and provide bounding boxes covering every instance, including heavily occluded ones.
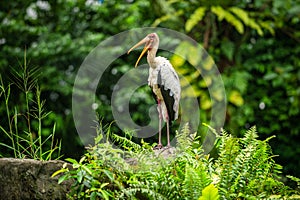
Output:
[53,124,300,200]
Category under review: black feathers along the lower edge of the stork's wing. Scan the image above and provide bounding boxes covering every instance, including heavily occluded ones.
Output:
[157,70,175,122]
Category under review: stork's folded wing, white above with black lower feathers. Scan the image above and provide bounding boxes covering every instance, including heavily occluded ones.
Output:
[156,57,181,121]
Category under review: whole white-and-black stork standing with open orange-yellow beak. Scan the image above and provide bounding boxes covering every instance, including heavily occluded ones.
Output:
[127,33,181,149]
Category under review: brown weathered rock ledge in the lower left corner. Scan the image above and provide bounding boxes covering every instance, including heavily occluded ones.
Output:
[0,158,72,200]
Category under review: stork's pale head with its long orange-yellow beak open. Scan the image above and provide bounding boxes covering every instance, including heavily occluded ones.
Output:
[127,33,159,67]
